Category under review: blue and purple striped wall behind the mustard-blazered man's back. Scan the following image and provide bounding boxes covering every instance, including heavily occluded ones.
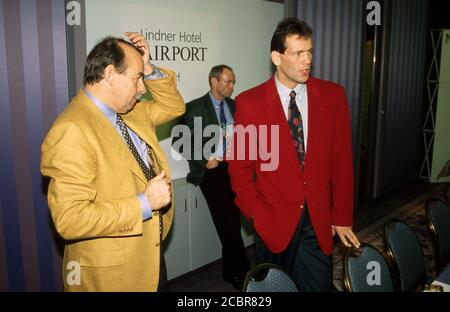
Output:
[0,0,68,291]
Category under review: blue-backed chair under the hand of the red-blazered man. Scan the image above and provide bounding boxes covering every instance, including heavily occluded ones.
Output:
[344,243,394,292]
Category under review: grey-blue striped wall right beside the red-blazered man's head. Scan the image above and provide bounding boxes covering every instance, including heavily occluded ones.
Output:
[297,0,366,159]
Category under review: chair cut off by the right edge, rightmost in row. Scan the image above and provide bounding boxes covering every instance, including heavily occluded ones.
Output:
[425,199,450,270]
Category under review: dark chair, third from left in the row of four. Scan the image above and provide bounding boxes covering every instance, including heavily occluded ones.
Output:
[384,219,425,291]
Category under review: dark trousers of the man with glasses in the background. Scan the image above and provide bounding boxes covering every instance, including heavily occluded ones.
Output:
[200,162,250,278]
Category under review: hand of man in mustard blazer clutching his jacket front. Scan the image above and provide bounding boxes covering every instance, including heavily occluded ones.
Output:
[144,170,171,211]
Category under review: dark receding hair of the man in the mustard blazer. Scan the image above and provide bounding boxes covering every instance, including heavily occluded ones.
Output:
[83,37,143,85]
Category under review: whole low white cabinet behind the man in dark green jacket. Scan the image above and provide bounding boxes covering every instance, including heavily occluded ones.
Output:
[164,178,254,279]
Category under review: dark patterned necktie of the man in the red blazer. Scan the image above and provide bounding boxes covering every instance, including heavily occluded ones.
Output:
[288,91,305,169]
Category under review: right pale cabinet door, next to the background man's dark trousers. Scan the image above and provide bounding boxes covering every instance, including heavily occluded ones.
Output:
[190,185,222,270]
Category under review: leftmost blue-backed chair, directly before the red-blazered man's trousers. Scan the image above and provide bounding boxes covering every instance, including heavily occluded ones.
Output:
[243,263,298,292]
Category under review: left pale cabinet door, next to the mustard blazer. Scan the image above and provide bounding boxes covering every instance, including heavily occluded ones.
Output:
[164,184,190,279]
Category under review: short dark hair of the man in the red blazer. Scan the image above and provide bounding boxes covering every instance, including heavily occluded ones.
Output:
[270,17,312,54]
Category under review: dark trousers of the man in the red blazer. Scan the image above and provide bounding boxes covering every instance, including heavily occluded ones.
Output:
[256,205,332,292]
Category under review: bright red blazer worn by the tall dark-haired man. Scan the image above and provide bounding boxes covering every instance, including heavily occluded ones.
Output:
[228,77,353,255]
